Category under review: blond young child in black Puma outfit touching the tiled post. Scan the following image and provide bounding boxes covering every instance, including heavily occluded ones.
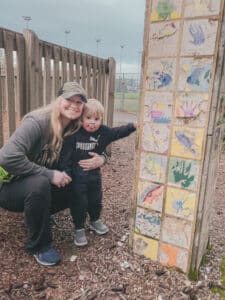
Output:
[60,99,136,246]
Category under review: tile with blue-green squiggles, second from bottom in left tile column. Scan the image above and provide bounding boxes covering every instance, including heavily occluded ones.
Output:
[135,207,161,239]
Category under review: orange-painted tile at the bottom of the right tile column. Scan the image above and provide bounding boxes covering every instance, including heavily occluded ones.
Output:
[159,244,188,272]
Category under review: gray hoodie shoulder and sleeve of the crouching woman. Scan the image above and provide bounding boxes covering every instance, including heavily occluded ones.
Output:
[0,113,53,180]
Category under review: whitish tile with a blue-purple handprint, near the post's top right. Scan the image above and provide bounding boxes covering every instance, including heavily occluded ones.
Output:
[181,19,218,55]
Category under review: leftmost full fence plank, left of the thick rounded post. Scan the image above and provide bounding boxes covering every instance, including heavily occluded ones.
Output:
[4,31,16,135]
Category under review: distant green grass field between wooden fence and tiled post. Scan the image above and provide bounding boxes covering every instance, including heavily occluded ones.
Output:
[114,93,139,112]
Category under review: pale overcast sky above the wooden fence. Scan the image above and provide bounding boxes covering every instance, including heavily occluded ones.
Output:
[0,0,145,73]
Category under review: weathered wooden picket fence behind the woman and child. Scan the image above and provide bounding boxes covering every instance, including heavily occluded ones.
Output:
[0,28,115,146]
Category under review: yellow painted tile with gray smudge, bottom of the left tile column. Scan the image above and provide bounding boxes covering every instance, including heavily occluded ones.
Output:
[133,233,159,260]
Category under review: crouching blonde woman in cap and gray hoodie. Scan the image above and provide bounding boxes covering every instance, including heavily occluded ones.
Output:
[0,82,104,265]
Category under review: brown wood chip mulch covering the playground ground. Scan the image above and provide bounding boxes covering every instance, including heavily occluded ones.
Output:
[0,134,225,300]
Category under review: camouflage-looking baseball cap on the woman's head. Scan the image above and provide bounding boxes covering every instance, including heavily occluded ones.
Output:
[57,81,87,102]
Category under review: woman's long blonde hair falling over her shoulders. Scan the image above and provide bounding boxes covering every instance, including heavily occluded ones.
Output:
[23,96,81,164]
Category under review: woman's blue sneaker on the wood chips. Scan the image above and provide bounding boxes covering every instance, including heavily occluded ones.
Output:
[34,247,61,266]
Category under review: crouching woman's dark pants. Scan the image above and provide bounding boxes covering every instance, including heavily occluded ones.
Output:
[0,175,73,253]
